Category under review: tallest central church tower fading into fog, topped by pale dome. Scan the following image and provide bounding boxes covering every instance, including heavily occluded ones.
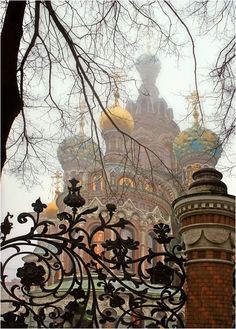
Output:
[127,54,179,172]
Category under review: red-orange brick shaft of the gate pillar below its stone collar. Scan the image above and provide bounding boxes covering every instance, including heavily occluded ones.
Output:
[186,261,233,328]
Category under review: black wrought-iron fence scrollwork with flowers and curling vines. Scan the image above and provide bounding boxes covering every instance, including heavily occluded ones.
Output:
[1,179,186,328]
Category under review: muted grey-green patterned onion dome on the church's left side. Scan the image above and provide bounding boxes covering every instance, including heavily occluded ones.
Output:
[57,135,98,169]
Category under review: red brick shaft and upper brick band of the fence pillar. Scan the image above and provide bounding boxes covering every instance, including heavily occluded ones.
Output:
[184,214,233,328]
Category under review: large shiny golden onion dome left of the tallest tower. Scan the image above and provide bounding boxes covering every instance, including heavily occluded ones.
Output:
[99,104,134,133]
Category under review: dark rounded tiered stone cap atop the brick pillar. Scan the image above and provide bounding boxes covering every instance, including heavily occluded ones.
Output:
[188,168,227,195]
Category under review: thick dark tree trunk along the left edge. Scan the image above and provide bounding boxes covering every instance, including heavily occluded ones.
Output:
[1,1,26,170]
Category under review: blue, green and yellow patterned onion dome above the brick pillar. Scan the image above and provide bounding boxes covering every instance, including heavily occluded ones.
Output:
[173,123,222,164]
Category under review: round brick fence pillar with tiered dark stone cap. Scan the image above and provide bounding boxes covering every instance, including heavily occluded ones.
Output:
[173,168,235,328]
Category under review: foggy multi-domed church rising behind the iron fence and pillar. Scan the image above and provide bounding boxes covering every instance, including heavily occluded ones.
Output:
[45,54,221,270]
